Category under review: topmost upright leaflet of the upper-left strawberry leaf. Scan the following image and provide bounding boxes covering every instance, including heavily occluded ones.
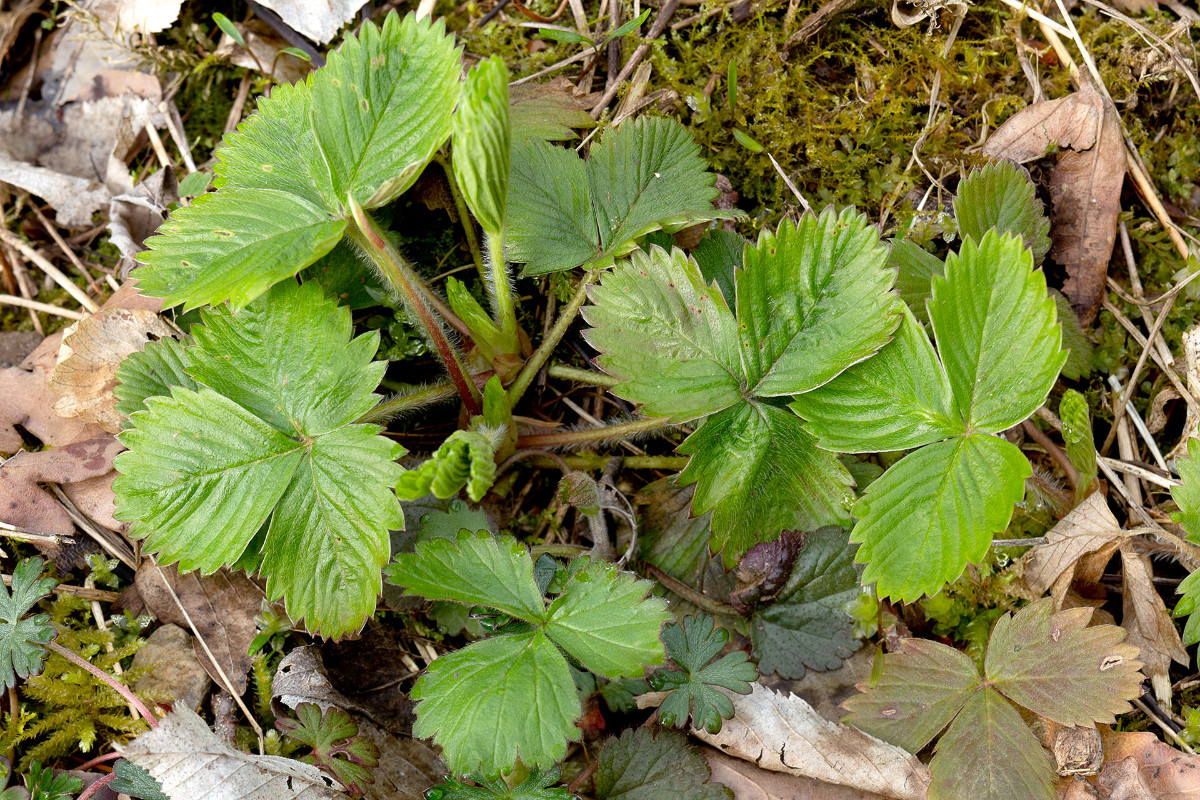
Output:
[312,13,460,209]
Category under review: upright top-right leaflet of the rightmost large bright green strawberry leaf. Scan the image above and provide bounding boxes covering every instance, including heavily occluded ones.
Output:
[929,231,1067,433]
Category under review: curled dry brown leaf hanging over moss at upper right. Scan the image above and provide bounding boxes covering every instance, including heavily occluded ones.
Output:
[983,88,1126,325]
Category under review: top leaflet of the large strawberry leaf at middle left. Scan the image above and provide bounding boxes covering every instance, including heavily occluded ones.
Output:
[187,281,388,437]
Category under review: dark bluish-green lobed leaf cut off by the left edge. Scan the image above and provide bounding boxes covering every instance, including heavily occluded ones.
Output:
[0,558,55,690]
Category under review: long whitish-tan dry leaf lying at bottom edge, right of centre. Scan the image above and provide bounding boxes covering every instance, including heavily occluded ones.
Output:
[691,684,929,800]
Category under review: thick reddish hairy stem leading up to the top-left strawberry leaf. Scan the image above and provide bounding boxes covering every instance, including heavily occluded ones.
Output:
[347,197,482,415]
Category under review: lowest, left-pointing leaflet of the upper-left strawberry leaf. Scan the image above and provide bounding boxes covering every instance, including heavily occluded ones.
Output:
[133,186,346,309]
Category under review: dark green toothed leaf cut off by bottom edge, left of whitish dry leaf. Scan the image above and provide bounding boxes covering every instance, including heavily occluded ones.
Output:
[594,728,732,800]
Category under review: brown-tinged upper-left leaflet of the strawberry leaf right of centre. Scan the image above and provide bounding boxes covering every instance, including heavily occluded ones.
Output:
[583,247,744,421]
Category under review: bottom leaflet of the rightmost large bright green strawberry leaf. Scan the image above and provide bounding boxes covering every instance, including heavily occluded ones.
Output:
[851,433,1032,601]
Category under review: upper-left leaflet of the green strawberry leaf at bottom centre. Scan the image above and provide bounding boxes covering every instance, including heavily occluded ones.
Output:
[384,530,545,621]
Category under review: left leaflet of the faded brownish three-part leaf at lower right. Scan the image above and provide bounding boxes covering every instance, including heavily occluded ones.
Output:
[842,639,979,753]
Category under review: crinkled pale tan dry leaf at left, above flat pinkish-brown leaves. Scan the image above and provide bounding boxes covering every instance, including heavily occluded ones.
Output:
[49,308,173,433]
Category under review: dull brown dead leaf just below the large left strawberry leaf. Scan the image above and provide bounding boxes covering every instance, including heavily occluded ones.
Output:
[134,560,263,694]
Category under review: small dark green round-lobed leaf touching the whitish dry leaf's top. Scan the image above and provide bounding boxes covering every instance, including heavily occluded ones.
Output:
[649,614,758,733]
